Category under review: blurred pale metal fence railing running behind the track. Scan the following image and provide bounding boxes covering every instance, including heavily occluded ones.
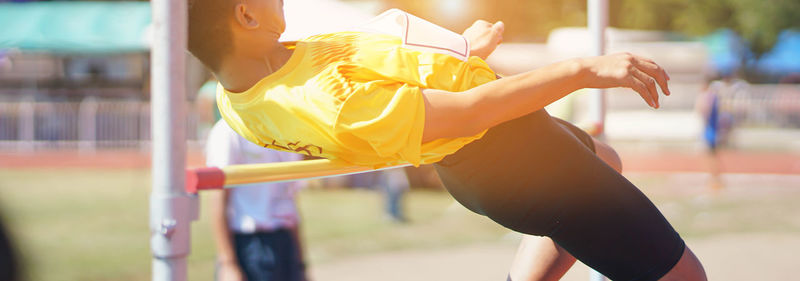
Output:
[0,83,800,151]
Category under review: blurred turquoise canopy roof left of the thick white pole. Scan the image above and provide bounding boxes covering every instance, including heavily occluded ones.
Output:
[0,2,151,53]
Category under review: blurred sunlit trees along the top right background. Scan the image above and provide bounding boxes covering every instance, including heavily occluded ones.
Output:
[376,0,800,56]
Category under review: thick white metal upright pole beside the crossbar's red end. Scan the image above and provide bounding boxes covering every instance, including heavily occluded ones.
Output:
[150,0,197,281]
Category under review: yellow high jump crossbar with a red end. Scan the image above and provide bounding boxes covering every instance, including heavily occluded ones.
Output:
[185,159,411,193]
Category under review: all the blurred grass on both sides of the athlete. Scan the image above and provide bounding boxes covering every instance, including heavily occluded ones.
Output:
[0,169,800,281]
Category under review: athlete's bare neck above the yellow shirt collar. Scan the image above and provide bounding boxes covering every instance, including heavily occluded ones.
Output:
[215,40,293,93]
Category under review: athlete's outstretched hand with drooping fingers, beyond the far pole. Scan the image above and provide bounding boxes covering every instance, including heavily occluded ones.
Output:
[583,53,670,108]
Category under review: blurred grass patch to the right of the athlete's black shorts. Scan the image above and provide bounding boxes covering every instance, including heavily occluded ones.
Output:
[633,177,800,238]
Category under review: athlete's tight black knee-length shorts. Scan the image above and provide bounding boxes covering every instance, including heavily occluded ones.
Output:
[435,110,685,280]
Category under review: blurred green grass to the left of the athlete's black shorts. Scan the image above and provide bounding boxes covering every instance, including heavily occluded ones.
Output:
[0,169,507,280]
